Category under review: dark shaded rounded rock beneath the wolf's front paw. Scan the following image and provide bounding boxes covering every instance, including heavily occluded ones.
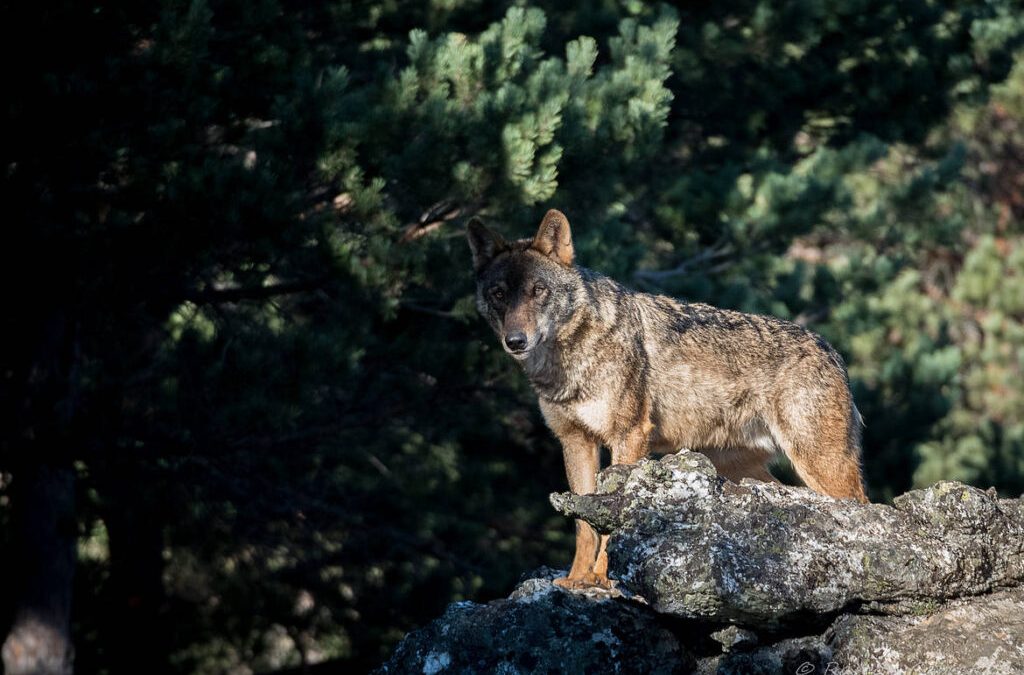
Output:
[379,579,694,675]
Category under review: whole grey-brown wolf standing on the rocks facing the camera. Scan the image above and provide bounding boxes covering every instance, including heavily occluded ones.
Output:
[467,210,867,588]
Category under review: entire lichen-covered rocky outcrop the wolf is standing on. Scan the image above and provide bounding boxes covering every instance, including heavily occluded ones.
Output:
[381,451,1024,675]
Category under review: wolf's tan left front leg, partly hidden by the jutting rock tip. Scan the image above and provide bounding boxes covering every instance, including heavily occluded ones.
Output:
[554,428,608,588]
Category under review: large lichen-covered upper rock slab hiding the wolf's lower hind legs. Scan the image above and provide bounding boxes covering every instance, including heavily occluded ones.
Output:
[552,451,1024,627]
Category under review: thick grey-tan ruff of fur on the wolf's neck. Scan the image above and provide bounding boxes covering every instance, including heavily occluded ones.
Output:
[522,267,642,403]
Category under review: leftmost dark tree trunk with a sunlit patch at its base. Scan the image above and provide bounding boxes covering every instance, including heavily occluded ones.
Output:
[0,307,78,675]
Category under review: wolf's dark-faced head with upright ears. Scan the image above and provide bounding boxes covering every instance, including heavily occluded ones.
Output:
[467,210,583,361]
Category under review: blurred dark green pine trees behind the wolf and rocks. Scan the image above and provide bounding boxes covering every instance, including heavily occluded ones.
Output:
[0,0,1024,674]
